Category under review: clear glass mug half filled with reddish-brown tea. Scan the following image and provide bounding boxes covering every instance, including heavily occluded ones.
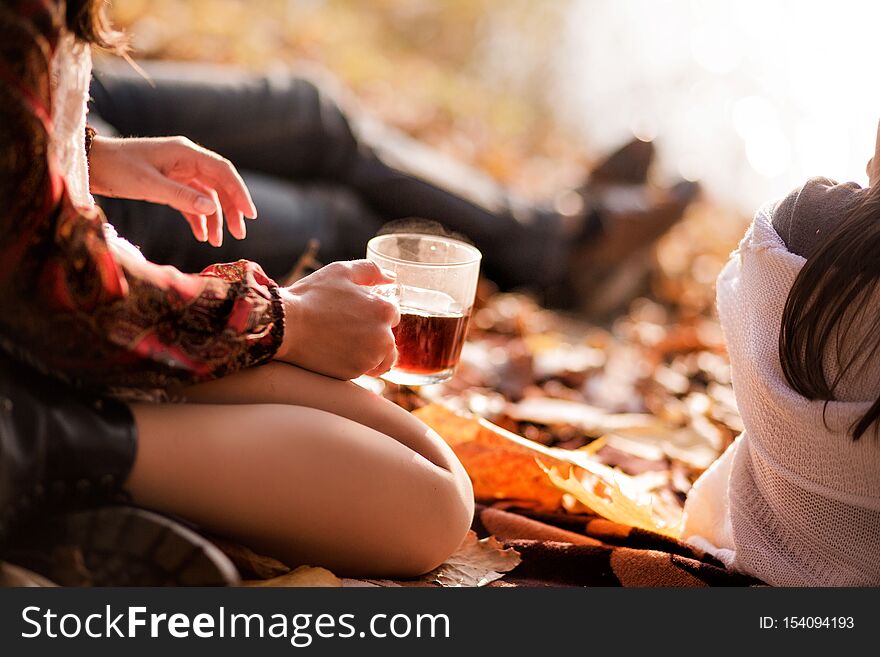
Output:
[367,233,482,386]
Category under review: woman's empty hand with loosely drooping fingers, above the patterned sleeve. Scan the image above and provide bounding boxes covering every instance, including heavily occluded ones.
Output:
[89,136,257,246]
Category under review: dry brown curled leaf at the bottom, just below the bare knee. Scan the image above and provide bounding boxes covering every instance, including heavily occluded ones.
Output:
[420,531,521,587]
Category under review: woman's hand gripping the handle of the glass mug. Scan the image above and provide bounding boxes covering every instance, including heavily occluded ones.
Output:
[275,260,400,380]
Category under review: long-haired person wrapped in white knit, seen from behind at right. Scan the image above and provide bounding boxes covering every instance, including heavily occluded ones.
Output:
[682,124,880,586]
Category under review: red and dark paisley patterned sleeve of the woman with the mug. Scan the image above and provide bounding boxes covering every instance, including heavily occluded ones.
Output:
[0,0,284,388]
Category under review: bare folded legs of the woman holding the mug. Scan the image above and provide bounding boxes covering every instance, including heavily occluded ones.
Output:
[128,365,473,576]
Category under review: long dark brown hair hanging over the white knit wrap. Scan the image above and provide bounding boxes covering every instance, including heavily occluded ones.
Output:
[779,186,880,440]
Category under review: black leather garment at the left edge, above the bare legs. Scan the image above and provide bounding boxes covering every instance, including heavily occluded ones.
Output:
[0,352,137,547]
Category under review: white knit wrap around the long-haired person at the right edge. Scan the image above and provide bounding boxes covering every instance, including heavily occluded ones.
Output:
[683,206,880,586]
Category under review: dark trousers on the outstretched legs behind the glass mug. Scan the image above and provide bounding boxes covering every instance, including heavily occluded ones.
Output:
[89,62,566,287]
